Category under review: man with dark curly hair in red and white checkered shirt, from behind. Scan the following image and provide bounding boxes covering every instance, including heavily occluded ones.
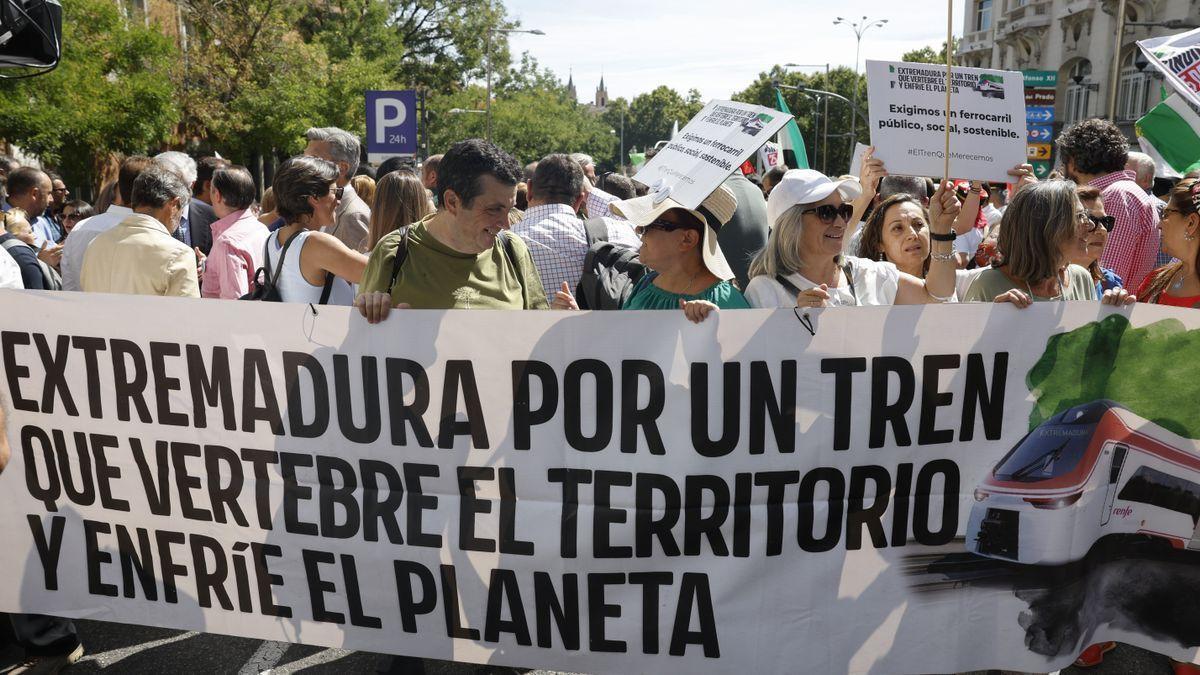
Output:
[1056,119,1160,288]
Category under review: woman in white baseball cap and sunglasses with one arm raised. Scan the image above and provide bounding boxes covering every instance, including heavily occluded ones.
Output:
[745,169,959,307]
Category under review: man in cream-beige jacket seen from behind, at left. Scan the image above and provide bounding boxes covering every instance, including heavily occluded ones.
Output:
[79,161,200,298]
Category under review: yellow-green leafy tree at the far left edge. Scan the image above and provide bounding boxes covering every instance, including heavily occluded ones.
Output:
[0,0,179,185]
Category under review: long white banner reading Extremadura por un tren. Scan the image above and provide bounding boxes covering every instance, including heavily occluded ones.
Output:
[0,291,1200,674]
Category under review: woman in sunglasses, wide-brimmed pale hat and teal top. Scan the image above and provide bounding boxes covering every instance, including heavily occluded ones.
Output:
[551,186,750,323]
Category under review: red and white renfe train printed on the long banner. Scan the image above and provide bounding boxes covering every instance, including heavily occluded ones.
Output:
[966,400,1200,565]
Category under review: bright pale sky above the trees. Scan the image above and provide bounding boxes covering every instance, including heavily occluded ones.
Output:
[506,0,964,102]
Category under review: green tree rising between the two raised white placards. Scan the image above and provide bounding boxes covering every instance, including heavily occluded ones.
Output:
[733,65,871,175]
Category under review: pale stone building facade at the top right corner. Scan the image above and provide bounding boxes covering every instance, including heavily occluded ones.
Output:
[958,0,1200,138]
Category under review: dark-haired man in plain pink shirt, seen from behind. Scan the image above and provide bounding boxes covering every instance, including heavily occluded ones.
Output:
[200,166,269,300]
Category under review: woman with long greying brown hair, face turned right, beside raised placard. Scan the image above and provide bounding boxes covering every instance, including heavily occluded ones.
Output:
[962,180,1136,307]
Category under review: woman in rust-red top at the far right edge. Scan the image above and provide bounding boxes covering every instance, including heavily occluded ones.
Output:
[1138,178,1200,309]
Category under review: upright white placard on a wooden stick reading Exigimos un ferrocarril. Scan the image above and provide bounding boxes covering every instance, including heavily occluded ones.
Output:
[866,61,1026,183]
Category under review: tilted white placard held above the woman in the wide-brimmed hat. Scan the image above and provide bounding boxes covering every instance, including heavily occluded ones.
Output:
[634,101,791,209]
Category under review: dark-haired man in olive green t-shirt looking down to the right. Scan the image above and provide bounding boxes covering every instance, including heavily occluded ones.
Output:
[354,138,548,323]
